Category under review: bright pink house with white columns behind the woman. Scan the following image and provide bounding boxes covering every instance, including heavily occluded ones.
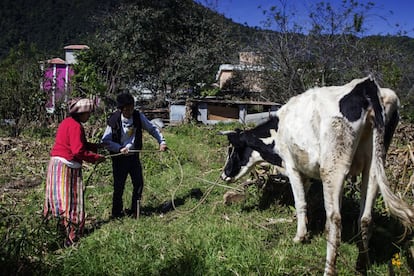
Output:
[40,45,89,113]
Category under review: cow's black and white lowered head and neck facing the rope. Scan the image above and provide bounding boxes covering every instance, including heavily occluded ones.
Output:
[221,118,282,182]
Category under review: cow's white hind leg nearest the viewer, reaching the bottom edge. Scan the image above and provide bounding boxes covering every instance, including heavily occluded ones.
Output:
[322,171,346,275]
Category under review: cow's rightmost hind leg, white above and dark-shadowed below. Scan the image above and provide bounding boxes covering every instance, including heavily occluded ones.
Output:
[356,166,378,273]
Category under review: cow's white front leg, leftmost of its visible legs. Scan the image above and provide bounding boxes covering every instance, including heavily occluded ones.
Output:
[288,169,308,242]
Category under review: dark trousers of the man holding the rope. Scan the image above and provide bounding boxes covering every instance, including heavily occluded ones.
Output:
[112,154,144,217]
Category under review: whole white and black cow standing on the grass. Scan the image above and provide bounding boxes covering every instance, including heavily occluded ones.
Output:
[222,77,414,275]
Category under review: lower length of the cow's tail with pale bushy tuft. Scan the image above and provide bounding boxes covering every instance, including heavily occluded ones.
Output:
[371,127,414,231]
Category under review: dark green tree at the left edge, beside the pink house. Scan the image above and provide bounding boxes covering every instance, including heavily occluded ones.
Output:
[0,43,46,136]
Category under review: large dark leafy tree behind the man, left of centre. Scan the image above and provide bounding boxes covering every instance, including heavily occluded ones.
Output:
[74,0,237,108]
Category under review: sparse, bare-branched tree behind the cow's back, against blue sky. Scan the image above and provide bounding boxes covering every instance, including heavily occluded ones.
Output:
[262,0,408,102]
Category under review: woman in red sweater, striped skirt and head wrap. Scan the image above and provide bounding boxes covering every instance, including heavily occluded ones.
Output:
[43,98,105,246]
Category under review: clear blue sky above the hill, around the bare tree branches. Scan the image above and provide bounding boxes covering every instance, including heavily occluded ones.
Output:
[197,0,414,37]
